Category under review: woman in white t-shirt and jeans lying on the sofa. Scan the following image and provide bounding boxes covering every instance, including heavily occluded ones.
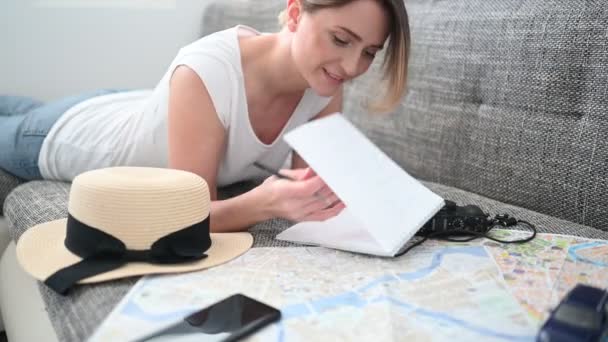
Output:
[0,0,409,232]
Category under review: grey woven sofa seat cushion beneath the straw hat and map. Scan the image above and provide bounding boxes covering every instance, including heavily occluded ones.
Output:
[5,181,608,341]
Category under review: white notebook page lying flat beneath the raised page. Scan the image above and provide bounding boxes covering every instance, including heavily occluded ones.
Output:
[276,209,392,256]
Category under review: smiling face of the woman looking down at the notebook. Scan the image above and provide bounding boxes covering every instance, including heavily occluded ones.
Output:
[292,0,388,96]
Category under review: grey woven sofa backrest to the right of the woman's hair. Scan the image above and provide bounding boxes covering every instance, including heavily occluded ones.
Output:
[344,0,608,230]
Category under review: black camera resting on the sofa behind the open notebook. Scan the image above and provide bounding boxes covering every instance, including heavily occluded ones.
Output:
[416,200,492,236]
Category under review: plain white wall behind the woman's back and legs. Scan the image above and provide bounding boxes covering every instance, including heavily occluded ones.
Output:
[0,0,209,100]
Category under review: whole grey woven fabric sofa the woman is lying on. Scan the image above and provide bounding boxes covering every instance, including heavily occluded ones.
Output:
[0,0,608,341]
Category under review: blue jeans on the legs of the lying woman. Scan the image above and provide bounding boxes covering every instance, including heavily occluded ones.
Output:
[0,89,118,180]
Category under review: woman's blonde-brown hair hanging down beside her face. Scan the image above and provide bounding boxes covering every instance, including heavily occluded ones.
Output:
[279,0,410,112]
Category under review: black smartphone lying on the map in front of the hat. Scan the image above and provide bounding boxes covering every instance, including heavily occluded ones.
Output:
[138,294,281,342]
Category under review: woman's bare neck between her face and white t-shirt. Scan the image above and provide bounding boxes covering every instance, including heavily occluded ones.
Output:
[240,30,308,101]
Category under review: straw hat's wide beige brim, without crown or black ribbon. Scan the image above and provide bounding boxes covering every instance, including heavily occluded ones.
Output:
[16,219,253,284]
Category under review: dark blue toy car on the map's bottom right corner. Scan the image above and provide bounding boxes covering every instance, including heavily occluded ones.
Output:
[536,284,608,342]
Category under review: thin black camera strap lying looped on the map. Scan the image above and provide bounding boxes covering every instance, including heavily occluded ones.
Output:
[395,214,536,257]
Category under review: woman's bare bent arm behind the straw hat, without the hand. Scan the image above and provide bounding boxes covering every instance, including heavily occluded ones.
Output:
[168,66,268,232]
